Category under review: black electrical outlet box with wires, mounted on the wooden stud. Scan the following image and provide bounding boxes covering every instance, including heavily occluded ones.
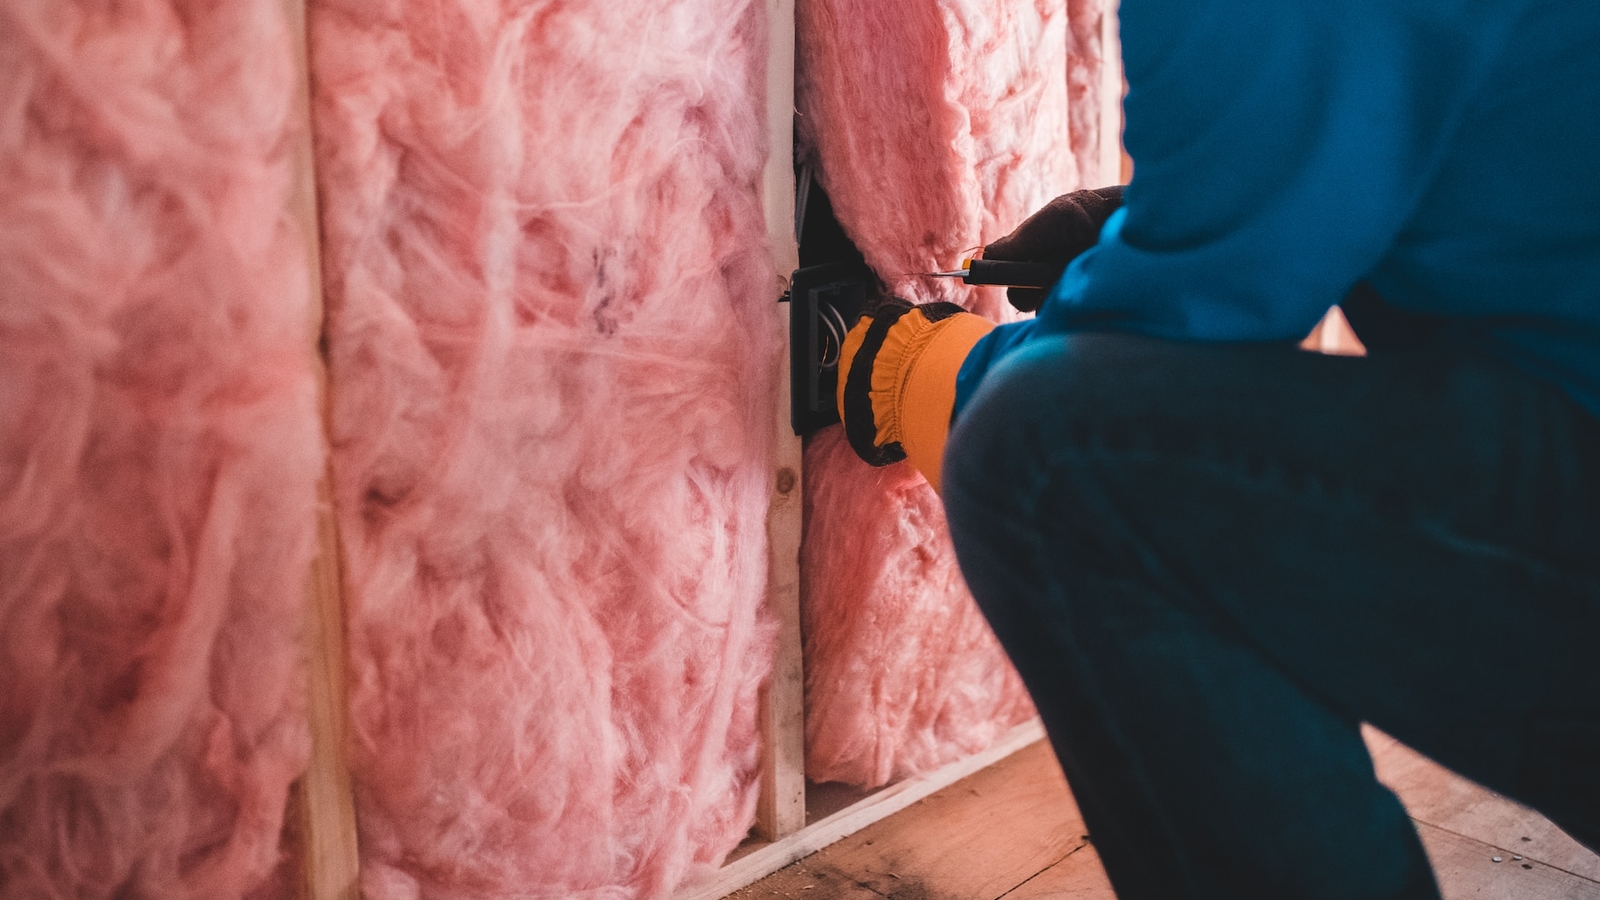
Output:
[789,261,878,437]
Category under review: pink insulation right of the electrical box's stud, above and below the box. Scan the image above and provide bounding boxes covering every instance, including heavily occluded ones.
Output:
[797,0,1110,786]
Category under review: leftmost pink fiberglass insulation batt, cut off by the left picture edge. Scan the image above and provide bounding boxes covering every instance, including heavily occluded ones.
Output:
[0,0,323,900]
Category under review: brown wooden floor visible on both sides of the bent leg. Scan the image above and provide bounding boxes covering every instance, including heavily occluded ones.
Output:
[733,732,1600,900]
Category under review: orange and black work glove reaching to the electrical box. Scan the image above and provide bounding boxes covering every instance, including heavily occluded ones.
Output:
[838,296,994,490]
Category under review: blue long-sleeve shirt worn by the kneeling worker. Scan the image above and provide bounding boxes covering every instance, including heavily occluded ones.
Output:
[957,0,1600,415]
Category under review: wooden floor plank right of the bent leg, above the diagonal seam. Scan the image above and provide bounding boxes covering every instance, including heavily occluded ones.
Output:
[1366,729,1600,882]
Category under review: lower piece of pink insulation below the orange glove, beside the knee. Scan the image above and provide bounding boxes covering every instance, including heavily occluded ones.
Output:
[800,428,1034,786]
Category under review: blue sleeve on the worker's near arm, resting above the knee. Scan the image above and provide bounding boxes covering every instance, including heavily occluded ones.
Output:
[957,0,1518,410]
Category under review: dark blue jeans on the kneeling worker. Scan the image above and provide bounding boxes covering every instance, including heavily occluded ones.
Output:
[944,335,1600,900]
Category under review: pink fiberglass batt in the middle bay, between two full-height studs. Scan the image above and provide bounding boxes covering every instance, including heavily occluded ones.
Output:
[312,0,779,900]
